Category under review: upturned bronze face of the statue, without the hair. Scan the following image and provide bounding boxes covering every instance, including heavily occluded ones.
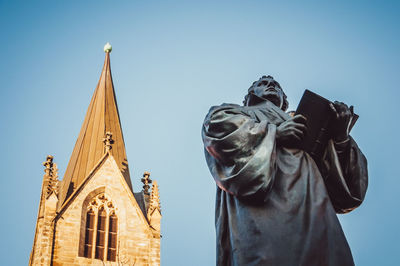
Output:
[252,78,284,108]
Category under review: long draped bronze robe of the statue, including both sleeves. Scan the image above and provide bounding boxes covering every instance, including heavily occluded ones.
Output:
[202,102,368,266]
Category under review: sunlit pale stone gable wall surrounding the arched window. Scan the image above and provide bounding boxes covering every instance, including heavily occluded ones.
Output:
[53,156,160,265]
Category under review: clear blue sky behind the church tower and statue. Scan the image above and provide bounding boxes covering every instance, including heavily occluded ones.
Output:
[0,0,400,266]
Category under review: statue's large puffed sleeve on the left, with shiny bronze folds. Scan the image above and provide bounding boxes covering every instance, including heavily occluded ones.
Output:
[202,107,276,200]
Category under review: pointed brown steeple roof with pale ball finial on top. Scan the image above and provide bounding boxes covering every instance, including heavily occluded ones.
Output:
[60,44,132,204]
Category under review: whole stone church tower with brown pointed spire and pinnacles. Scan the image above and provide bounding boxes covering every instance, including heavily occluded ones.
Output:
[29,43,161,265]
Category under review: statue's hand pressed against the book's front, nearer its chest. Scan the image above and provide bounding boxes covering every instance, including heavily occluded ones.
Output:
[276,115,307,147]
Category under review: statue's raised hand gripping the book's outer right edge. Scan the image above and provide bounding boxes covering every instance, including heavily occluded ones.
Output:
[330,101,354,142]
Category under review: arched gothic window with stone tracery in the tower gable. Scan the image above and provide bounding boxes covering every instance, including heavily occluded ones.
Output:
[80,194,118,261]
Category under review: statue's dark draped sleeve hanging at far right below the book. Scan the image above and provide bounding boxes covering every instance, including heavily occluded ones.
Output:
[322,137,368,213]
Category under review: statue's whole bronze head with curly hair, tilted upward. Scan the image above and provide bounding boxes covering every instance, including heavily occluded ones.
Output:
[243,76,289,111]
